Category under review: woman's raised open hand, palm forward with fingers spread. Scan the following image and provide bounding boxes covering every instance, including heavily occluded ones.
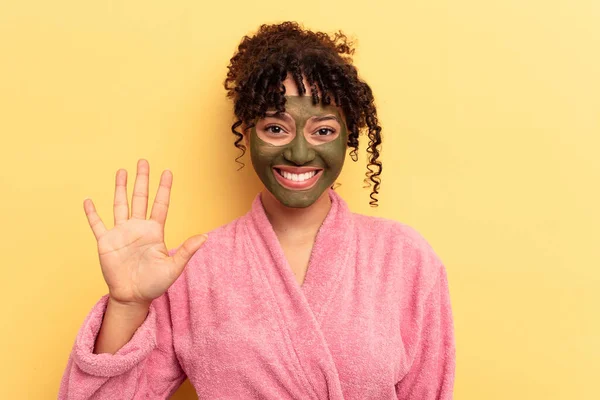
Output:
[83,159,206,305]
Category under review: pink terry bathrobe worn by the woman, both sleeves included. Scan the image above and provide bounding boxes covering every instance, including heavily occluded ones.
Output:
[59,190,455,400]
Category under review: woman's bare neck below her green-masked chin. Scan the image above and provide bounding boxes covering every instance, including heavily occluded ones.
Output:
[261,189,331,240]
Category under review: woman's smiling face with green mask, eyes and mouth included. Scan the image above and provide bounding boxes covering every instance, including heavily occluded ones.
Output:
[249,95,348,208]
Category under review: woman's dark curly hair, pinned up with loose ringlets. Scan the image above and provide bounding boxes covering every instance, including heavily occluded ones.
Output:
[224,21,382,207]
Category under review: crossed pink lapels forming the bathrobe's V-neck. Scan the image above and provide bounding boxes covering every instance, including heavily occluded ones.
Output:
[245,189,356,399]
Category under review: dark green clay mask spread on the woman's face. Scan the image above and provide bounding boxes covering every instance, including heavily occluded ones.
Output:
[250,96,348,208]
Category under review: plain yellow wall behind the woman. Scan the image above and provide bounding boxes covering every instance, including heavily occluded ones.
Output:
[0,0,600,400]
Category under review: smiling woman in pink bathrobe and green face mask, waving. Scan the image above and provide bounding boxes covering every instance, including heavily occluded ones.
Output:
[59,22,454,400]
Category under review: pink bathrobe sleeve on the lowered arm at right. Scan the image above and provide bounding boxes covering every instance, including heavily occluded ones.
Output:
[396,266,455,400]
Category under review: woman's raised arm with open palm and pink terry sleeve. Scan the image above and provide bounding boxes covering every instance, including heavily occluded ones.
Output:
[59,159,206,400]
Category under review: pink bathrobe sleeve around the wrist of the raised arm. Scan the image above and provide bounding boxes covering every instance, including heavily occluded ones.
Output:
[58,292,185,400]
